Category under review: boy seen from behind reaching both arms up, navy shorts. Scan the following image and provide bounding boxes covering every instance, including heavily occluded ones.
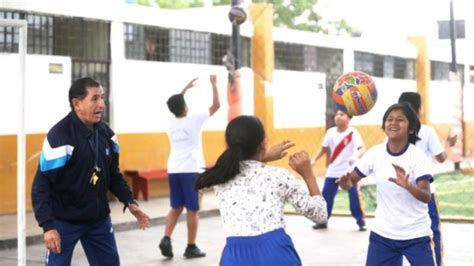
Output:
[159,75,220,258]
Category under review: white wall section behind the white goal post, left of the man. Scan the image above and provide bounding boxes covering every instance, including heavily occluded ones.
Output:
[0,53,71,135]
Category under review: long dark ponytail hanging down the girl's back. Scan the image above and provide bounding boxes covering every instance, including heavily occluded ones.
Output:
[195,145,244,190]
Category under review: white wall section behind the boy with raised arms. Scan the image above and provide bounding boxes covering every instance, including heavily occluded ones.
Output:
[113,60,253,133]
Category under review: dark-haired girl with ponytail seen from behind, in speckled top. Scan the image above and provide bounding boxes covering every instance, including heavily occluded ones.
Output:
[196,116,327,266]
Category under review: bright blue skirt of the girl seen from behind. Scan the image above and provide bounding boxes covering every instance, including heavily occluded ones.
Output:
[220,229,301,266]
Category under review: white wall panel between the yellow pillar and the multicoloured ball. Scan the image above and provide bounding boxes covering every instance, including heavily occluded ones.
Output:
[270,70,326,128]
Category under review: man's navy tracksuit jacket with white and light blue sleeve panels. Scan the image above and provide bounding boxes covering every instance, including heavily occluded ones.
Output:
[31,112,133,232]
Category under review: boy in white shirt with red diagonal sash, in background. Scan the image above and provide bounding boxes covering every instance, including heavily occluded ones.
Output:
[312,110,366,231]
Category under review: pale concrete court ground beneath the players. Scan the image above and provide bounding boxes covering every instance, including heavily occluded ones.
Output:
[0,213,474,266]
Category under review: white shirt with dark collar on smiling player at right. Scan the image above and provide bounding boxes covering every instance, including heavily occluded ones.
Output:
[354,142,433,240]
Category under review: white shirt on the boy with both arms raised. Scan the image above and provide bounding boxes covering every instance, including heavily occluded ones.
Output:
[167,112,209,173]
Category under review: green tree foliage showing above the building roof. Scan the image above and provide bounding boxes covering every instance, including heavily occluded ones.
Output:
[137,0,354,34]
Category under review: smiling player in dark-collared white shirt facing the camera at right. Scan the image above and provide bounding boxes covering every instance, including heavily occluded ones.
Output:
[339,103,435,266]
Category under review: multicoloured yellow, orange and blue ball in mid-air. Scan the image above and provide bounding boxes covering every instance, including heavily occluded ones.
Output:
[332,71,377,116]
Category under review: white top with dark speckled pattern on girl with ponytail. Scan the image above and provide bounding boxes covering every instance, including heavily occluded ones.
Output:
[214,161,327,236]
